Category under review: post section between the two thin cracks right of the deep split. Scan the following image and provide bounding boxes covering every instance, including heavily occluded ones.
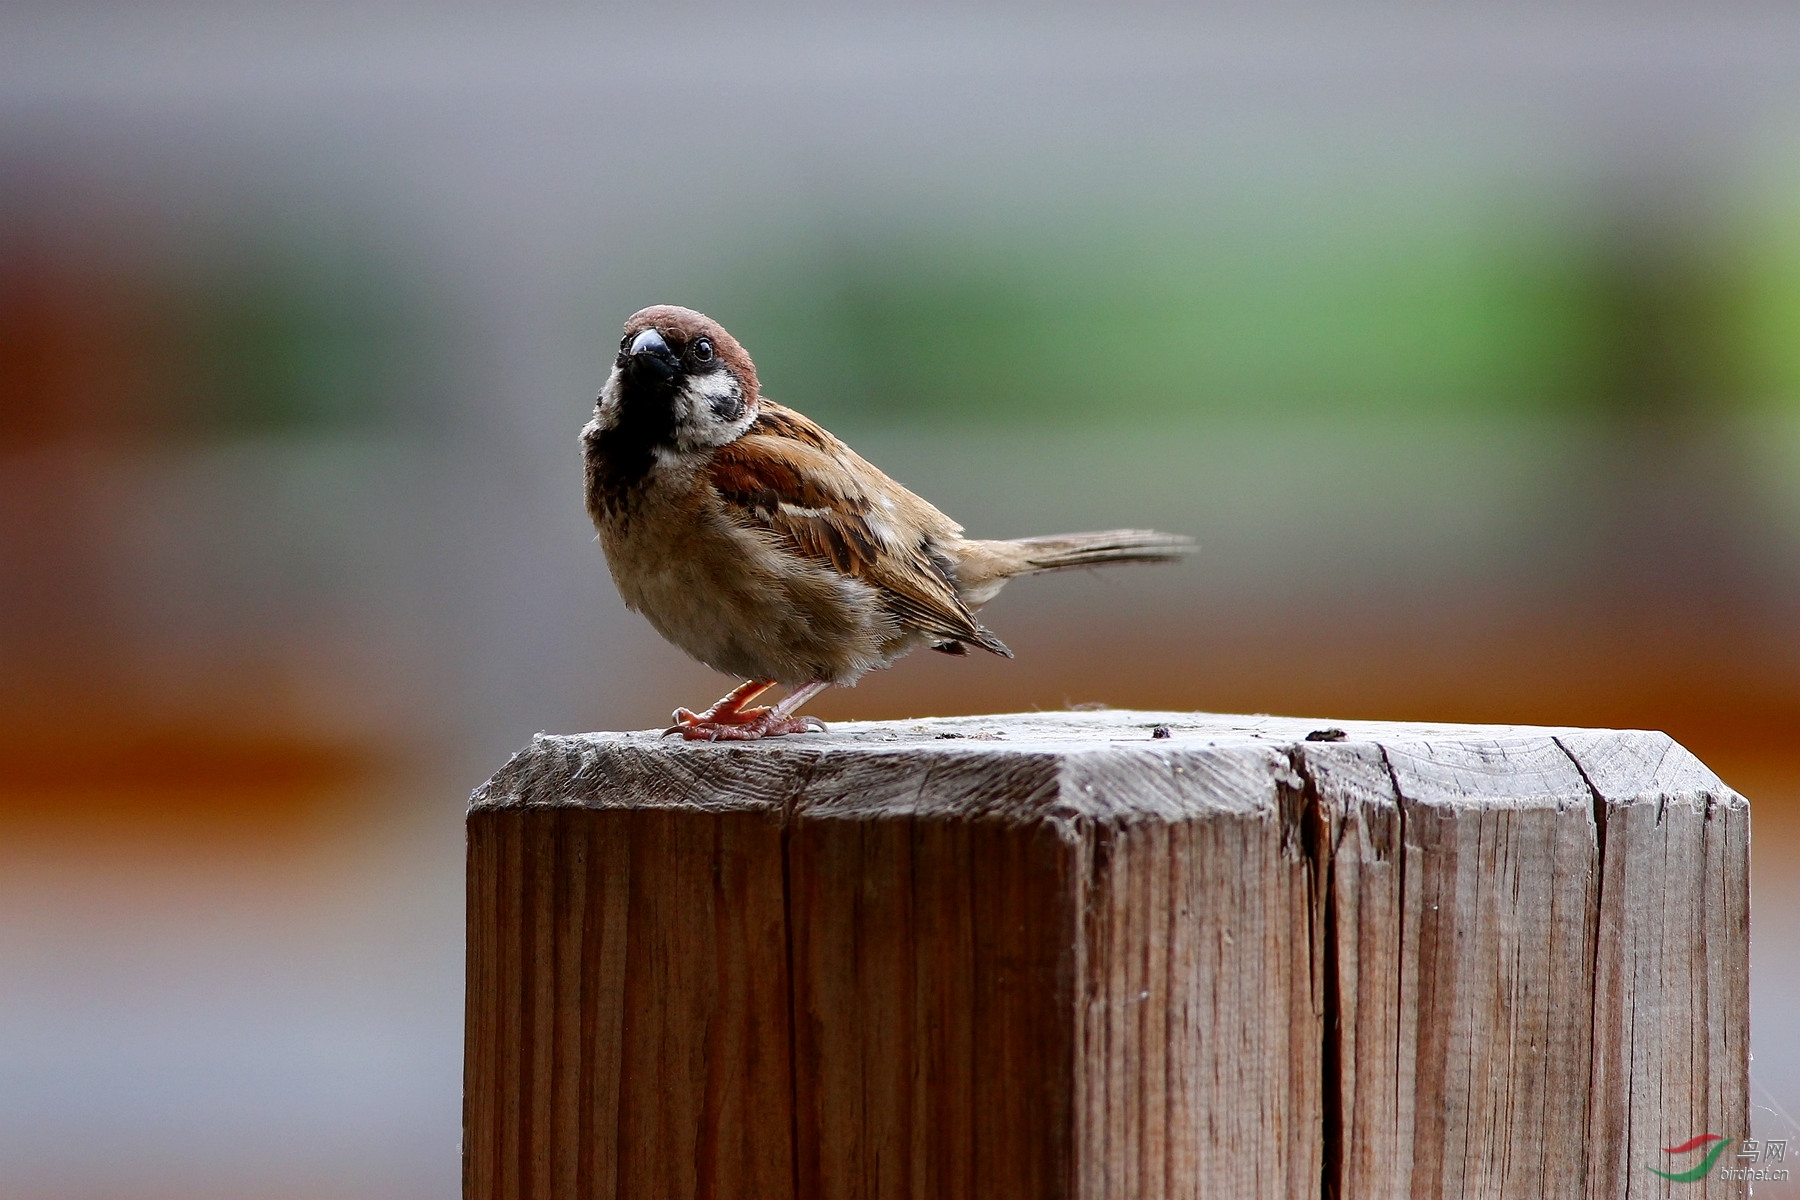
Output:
[1384,738,1598,1196]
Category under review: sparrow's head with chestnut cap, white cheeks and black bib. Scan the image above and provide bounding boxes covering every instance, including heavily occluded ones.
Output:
[596,304,758,452]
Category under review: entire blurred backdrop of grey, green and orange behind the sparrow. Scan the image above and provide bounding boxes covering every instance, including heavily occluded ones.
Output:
[0,0,1800,1200]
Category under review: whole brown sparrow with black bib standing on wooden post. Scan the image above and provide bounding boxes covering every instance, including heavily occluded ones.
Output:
[581,304,1195,741]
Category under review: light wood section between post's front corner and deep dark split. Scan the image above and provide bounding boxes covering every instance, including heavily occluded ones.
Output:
[1064,745,1323,1196]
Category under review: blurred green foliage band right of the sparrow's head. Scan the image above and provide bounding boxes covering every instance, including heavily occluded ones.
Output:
[715,199,1800,423]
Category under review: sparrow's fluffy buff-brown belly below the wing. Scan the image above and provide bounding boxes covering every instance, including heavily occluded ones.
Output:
[601,520,896,685]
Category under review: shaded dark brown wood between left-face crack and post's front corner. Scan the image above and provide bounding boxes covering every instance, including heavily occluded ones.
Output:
[788,754,1080,1196]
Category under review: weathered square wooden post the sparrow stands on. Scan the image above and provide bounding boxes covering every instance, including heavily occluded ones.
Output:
[464,711,1750,1200]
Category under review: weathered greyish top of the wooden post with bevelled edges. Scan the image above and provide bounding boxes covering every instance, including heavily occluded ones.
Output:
[472,709,1742,820]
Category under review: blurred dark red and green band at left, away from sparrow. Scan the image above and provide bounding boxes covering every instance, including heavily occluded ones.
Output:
[0,212,435,448]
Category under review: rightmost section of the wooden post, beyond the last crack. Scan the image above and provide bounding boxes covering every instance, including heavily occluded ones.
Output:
[1559,732,1750,1196]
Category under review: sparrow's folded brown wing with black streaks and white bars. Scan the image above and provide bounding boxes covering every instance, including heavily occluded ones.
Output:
[711,399,1010,657]
